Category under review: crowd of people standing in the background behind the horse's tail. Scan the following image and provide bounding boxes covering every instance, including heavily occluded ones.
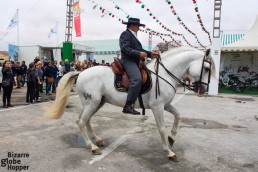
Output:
[0,57,109,108]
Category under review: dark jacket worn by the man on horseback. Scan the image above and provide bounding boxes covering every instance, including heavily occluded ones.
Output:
[119,29,151,64]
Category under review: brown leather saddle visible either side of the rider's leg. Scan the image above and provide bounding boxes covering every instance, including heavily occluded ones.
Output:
[111,58,148,91]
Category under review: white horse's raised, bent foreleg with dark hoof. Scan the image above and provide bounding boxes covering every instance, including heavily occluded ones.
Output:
[165,104,180,146]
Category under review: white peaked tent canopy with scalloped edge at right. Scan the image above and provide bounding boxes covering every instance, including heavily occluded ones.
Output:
[221,15,258,51]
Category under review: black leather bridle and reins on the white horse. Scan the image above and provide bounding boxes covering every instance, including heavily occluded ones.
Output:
[147,52,211,99]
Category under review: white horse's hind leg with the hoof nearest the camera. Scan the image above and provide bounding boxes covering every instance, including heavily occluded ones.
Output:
[77,104,101,155]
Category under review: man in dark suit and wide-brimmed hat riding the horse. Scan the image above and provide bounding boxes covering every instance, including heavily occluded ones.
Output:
[119,18,159,115]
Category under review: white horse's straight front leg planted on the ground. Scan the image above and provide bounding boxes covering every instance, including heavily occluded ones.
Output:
[151,106,178,161]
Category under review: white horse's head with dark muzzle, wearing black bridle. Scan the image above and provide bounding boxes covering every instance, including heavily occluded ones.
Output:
[185,49,215,96]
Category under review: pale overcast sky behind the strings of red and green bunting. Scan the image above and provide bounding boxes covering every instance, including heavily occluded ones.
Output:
[0,0,258,50]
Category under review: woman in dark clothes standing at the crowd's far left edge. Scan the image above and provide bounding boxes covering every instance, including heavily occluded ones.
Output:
[2,61,15,108]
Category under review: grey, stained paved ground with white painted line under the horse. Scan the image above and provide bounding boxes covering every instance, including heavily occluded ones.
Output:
[0,88,258,172]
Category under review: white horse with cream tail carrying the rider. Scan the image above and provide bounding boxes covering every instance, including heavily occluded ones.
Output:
[47,47,214,161]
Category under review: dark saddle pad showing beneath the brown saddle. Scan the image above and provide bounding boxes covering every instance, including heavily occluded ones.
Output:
[114,72,152,94]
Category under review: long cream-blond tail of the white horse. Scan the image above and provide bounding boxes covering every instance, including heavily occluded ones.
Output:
[46,71,80,119]
